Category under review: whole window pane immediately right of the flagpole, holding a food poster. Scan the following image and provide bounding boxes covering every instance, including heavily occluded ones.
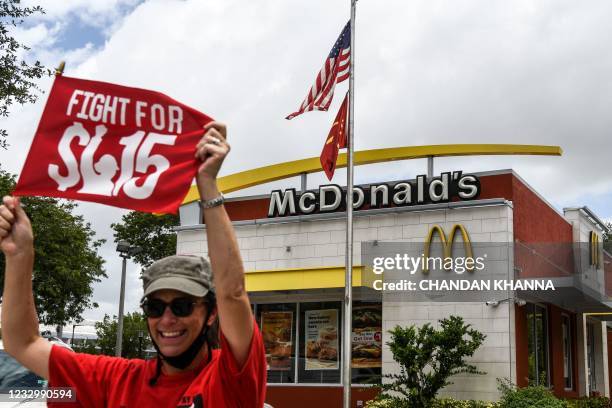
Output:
[351,302,382,384]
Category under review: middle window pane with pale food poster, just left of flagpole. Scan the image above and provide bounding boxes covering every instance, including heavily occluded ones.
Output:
[298,302,342,384]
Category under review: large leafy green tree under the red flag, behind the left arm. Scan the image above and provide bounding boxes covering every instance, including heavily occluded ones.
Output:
[0,169,107,326]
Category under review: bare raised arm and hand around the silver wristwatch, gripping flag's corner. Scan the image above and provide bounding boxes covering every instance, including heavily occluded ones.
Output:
[196,122,253,366]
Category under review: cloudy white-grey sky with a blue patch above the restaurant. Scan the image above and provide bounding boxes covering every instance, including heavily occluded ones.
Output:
[0,0,612,326]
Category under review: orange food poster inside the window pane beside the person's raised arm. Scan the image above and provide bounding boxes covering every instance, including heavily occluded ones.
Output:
[261,312,293,371]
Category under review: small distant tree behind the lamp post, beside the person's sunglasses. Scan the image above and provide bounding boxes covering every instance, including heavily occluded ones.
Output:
[96,312,151,358]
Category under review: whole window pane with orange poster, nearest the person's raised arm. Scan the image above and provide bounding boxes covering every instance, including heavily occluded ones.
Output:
[256,303,297,383]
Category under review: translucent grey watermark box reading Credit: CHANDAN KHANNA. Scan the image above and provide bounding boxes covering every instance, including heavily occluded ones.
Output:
[361,239,558,302]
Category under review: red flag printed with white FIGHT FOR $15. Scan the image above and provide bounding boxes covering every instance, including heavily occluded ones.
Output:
[14,76,212,213]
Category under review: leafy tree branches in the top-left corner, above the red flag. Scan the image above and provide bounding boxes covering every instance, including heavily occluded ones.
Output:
[0,0,51,149]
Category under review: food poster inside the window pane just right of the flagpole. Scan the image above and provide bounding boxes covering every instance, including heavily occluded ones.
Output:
[351,304,382,368]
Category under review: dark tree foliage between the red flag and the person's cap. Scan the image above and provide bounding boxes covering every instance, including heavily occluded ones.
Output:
[111,211,179,268]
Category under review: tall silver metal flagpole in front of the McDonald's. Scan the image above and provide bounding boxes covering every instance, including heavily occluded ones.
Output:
[342,0,357,408]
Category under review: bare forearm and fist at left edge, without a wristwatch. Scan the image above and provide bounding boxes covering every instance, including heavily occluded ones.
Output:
[0,196,52,379]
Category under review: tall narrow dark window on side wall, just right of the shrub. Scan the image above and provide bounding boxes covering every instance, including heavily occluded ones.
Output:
[526,303,550,387]
